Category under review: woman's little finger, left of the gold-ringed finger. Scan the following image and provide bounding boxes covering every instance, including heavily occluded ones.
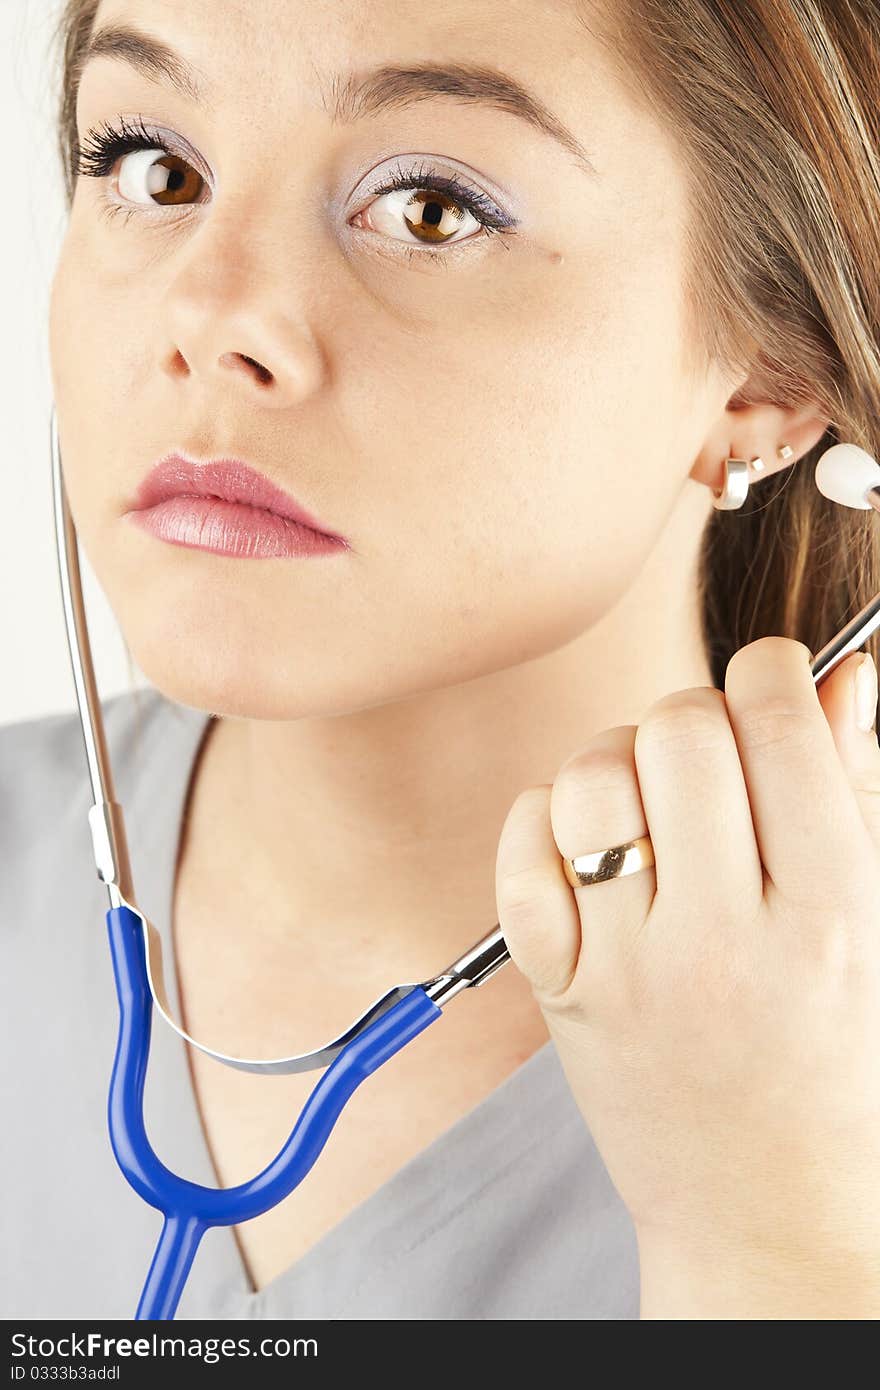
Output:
[495,783,581,999]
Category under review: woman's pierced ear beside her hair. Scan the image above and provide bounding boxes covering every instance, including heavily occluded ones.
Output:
[690,374,830,491]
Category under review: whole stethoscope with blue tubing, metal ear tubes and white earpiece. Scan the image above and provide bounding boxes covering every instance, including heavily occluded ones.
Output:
[50,404,880,1319]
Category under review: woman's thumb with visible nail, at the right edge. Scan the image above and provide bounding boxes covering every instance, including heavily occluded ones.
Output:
[816,652,880,849]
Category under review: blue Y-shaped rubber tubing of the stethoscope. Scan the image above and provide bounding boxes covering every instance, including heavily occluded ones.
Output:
[107,906,442,1321]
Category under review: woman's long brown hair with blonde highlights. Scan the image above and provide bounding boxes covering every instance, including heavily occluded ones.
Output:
[49,0,880,689]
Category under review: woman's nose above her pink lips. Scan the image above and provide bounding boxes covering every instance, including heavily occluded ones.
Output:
[157,211,324,409]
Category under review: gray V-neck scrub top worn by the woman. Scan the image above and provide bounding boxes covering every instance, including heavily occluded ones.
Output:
[0,688,638,1321]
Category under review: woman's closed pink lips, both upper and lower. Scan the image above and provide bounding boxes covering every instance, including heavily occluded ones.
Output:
[127,453,350,559]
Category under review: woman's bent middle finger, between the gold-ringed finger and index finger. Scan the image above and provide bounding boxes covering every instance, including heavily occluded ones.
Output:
[635,685,763,922]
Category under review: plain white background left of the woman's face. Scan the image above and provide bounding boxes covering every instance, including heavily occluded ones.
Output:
[0,0,145,724]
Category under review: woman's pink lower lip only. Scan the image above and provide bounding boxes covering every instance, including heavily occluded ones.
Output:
[127,493,348,560]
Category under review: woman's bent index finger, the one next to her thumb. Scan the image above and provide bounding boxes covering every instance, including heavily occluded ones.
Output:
[724,637,870,909]
